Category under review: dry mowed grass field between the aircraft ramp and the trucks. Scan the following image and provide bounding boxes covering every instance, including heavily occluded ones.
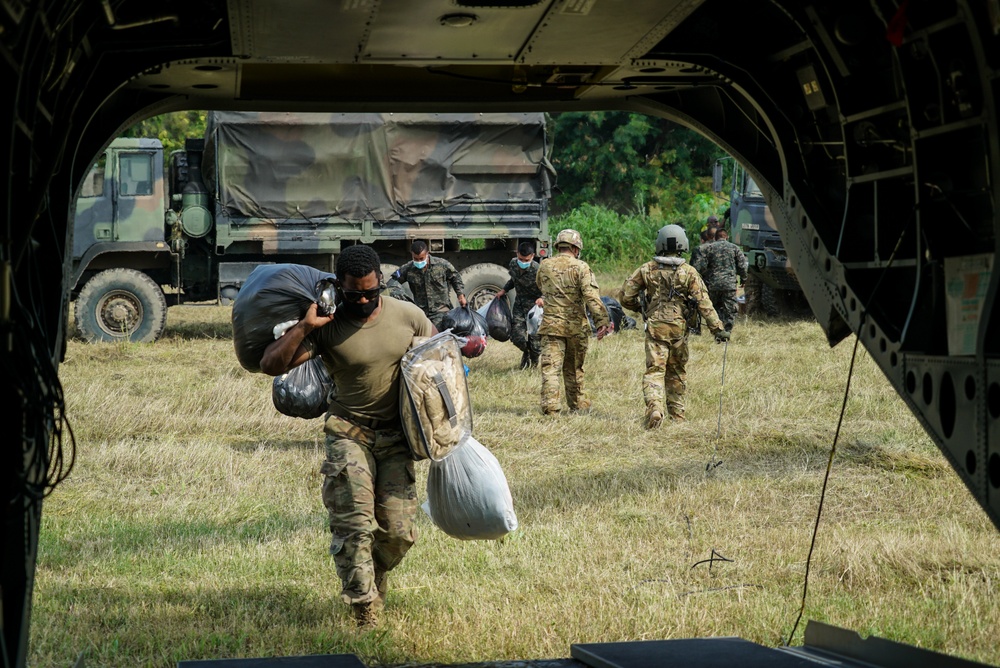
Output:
[29,294,1000,666]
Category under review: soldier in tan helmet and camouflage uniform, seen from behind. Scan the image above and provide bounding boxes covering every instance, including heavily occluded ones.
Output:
[536,229,611,415]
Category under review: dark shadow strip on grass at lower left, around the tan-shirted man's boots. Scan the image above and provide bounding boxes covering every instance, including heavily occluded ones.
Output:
[32,566,394,666]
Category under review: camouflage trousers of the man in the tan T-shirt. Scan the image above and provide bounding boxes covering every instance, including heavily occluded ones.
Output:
[320,415,417,604]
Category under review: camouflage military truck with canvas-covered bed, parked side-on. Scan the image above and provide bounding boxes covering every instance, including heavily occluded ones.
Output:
[70,112,554,342]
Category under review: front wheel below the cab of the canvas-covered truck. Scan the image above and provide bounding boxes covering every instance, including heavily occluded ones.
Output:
[76,269,167,343]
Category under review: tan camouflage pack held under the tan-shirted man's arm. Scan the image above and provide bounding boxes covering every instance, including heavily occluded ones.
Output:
[399,331,472,460]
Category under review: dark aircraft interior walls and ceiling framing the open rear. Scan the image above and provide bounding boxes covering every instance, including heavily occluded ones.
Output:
[0,0,1000,666]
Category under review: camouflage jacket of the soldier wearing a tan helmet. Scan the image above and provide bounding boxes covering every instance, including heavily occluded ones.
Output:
[535,254,610,336]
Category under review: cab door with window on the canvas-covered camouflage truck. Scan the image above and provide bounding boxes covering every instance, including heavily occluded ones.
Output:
[111,151,165,241]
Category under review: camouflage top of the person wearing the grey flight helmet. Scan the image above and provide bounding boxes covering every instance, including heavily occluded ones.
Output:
[621,257,722,341]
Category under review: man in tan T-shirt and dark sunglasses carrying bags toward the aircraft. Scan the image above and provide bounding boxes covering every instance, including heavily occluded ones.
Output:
[260,245,436,627]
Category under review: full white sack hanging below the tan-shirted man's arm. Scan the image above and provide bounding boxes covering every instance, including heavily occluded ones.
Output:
[421,436,517,540]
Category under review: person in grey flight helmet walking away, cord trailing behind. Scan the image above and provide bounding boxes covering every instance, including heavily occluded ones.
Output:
[621,225,729,429]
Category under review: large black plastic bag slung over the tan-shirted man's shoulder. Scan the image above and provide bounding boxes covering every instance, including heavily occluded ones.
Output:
[232,264,336,373]
